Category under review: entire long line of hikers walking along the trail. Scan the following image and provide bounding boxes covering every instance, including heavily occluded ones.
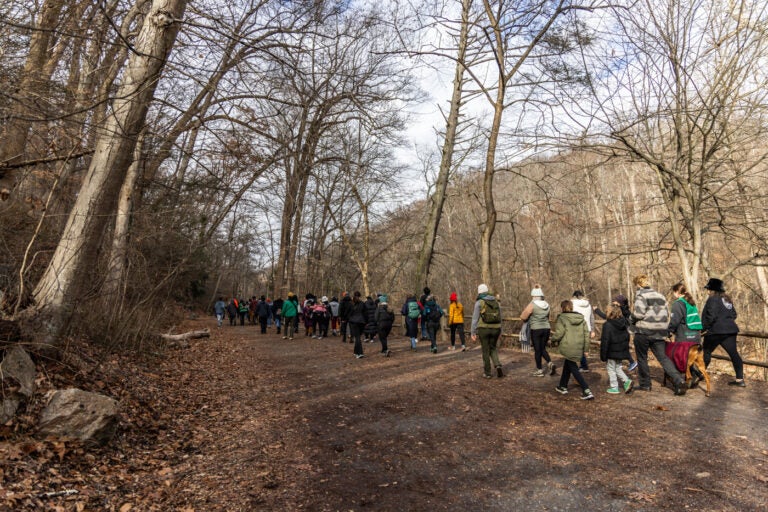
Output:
[214,274,746,400]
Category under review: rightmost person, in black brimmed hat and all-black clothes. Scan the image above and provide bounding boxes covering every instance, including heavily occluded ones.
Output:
[701,278,747,388]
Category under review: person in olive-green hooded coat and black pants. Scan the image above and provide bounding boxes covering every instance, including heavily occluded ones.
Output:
[552,300,595,400]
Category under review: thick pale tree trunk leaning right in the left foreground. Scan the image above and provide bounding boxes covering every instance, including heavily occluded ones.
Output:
[31,0,187,344]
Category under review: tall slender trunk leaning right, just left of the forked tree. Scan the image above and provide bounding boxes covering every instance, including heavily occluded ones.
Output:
[416,0,472,288]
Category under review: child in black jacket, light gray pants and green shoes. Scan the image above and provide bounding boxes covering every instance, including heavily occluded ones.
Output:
[600,304,632,395]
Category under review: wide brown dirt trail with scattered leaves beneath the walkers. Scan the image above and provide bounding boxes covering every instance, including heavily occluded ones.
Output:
[1,319,768,511]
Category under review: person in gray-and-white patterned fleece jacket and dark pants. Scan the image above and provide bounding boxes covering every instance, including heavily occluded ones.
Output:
[630,274,686,396]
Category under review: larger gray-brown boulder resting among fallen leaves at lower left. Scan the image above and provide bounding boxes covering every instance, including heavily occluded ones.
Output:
[37,388,119,444]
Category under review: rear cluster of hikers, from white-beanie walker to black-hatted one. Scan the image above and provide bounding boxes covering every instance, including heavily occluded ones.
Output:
[520,274,746,400]
